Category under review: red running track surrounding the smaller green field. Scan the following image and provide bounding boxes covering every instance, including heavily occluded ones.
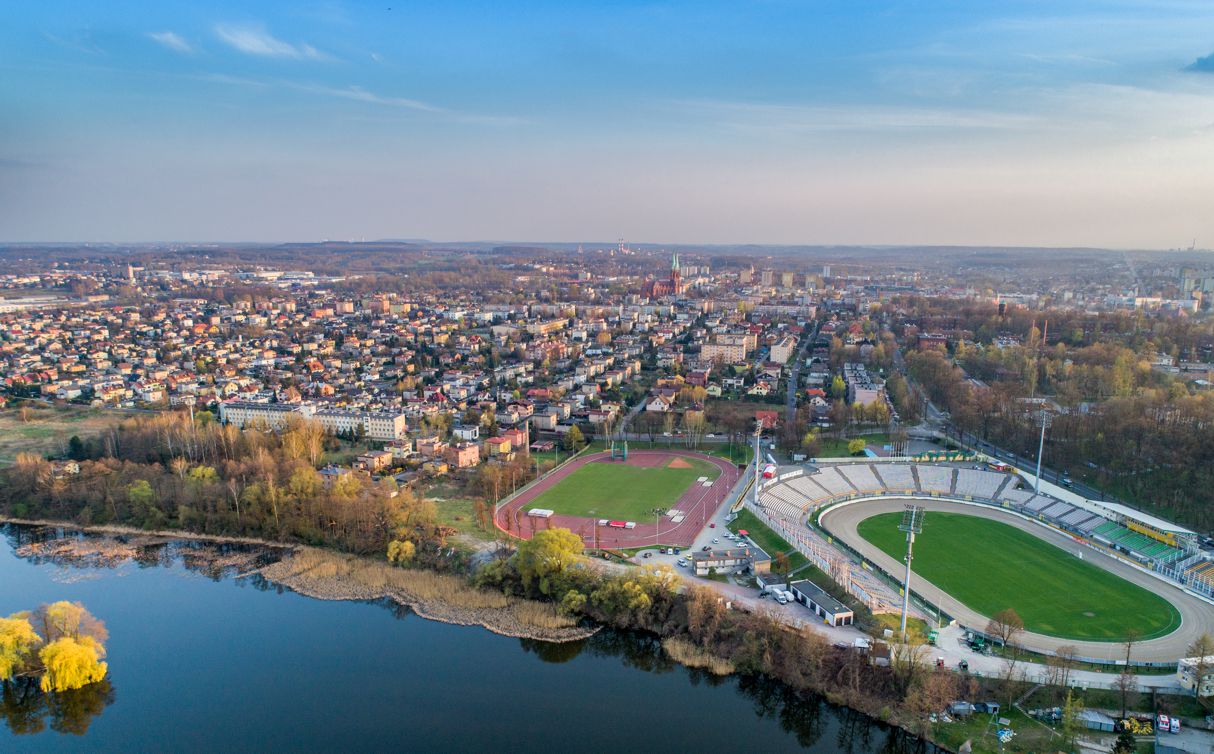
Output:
[495,450,742,549]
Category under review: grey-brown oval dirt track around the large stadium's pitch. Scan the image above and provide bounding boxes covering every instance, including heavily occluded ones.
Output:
[819,498,1214,662]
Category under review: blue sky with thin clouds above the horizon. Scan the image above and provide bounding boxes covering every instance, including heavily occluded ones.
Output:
[0,0,1214,248]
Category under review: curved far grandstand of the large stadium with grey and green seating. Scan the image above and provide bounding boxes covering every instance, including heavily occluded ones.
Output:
[758,461,1214,597]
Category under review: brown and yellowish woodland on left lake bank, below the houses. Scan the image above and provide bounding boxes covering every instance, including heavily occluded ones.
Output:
[0,413,420,552]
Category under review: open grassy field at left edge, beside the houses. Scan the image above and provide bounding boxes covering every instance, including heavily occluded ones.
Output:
[0,402,126,464]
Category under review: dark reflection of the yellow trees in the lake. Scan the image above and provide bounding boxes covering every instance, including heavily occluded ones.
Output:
[0,678,114,736]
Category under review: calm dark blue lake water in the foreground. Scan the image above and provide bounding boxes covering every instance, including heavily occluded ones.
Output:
[0,528,917,754]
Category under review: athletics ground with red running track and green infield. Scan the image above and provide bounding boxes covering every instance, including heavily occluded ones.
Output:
[495,450,741,549]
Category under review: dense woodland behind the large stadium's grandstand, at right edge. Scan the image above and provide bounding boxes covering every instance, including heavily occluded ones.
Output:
[907,346,1214,532]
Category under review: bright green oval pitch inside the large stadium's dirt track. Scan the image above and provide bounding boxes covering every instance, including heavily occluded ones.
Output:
[858,511,1180,641]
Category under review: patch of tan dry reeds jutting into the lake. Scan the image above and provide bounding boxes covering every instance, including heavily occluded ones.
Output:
[261,548,586,641]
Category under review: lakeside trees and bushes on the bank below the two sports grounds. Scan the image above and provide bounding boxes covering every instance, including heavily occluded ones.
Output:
[473,528,974,735]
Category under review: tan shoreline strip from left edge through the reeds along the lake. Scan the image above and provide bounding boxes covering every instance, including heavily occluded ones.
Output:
[0,516,600,642]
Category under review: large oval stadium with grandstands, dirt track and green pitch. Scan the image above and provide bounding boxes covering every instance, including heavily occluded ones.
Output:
[750,460,1214,663]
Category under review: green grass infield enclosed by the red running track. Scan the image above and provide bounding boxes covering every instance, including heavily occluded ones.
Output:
[523,458,720,523]
